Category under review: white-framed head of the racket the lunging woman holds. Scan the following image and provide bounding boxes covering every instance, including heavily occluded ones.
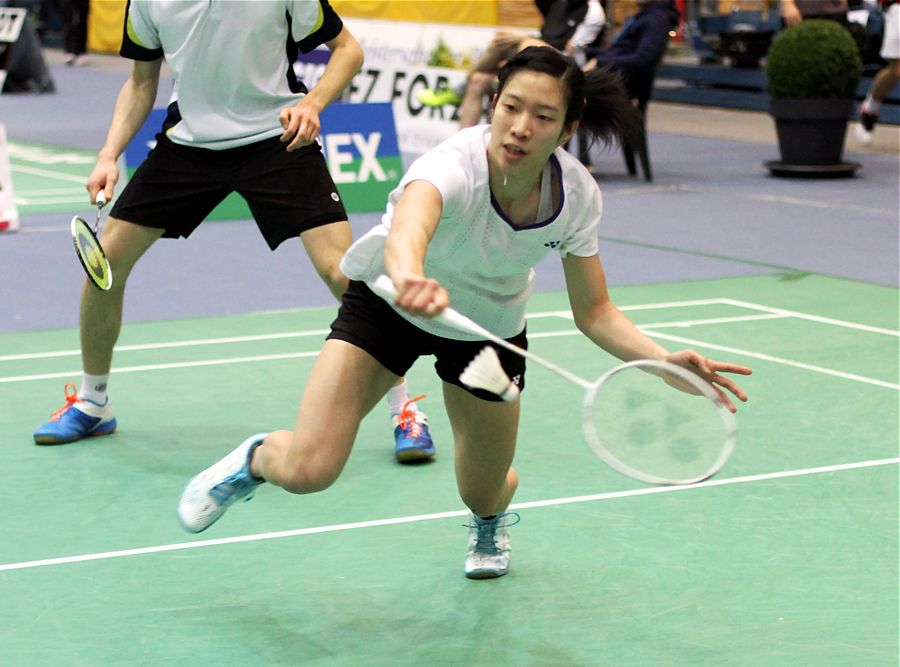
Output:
[582,359,738,485]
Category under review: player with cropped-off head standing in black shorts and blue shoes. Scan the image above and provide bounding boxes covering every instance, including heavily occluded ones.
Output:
[34,0,434,461]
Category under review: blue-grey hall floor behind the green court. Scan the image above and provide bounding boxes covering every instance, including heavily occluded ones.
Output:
[0,57,900,331]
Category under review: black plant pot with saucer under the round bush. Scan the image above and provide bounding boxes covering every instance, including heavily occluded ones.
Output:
[766,99,859,178]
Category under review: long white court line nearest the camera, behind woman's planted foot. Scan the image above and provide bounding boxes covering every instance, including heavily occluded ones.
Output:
[0,458,900,572]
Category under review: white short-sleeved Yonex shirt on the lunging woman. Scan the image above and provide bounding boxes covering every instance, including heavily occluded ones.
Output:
[341,125,602,340]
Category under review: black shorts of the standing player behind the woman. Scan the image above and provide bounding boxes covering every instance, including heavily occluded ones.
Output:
[110,133,347,250]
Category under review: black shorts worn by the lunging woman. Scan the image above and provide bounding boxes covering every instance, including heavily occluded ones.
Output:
[328,280,528,401]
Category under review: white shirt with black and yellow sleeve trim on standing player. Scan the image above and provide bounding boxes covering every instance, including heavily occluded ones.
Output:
[121,0,343,150]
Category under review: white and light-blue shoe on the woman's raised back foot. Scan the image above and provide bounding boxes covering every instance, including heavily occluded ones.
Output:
[178,433,268,533]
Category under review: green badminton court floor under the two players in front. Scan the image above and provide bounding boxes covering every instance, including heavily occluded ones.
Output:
[0,276,900,667]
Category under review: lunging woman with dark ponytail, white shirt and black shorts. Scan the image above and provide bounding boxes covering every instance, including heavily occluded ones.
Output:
[178,47,750,579]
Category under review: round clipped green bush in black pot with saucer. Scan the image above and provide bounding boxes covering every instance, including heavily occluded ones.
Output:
[766,19,862,177]
